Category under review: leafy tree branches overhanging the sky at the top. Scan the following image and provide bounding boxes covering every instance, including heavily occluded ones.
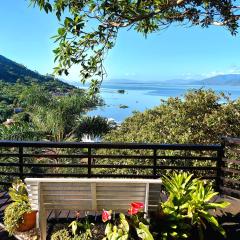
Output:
[29,0,240,92]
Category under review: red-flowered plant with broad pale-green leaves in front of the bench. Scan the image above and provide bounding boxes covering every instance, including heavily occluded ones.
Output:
[102,202,153,240]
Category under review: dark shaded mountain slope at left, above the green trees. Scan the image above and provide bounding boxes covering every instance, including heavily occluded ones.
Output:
[0,55,73,89]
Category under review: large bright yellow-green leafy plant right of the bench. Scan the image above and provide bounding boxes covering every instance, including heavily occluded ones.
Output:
[158,173,229,240]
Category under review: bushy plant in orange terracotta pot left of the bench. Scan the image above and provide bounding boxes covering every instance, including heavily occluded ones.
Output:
[4,180,37,235]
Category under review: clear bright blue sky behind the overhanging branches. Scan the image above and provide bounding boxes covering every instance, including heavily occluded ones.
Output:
[0,0,240,81]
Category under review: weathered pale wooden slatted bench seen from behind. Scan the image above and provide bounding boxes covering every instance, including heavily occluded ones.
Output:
[25,178,162,240]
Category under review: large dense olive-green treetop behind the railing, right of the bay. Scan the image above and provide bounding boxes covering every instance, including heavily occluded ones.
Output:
[104,90,240,144]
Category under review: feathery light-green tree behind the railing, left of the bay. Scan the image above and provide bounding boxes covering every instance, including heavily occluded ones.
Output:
[14,84,102,141]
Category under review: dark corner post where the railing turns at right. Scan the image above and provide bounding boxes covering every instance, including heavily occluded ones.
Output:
[216,139,225,194]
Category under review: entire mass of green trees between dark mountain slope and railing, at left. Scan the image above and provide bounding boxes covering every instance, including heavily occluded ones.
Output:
[0,81,111,141]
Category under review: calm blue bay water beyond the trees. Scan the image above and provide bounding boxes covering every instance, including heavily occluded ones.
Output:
[83,82,240,123]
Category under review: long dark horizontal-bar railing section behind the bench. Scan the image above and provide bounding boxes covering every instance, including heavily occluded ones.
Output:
[0,141,223,186]
